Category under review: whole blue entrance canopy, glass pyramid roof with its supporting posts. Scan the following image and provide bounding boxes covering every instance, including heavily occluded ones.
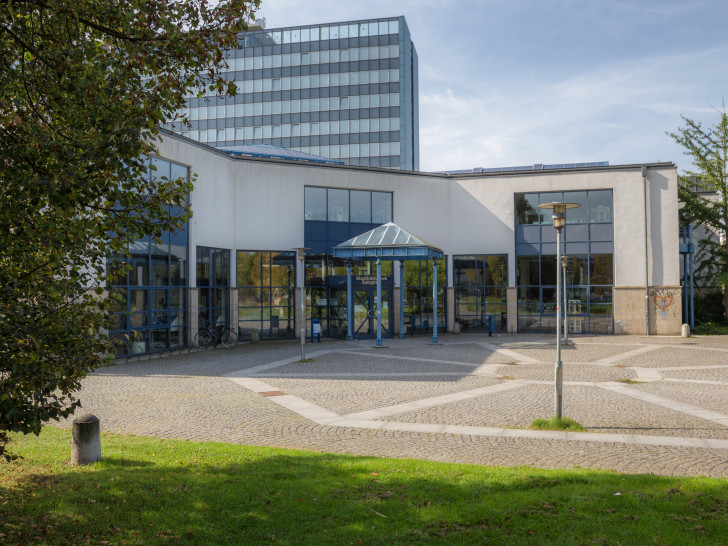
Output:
[334,222,445,347]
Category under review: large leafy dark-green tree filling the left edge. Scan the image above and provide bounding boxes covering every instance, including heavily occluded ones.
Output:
[0,0,259,458]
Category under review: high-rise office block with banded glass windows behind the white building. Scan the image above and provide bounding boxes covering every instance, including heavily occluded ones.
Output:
[170,17,419,171]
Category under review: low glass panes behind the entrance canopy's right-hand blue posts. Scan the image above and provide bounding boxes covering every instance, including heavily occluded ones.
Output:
[404,258,447,334]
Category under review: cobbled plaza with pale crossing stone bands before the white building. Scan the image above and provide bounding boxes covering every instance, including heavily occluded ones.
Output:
[60,334,728,477]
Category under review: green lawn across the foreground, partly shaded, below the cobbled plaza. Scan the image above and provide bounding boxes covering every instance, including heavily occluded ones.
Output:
[0,428,728,545]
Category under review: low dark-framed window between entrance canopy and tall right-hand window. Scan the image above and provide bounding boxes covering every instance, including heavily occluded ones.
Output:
[453,254,508,332]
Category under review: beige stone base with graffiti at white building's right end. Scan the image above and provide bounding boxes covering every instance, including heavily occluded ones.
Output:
[613,286,682,336]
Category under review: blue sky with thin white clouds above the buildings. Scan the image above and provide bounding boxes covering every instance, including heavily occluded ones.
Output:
[252,0,728,171]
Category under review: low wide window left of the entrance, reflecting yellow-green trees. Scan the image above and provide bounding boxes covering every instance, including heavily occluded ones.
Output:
[237,250,296,339]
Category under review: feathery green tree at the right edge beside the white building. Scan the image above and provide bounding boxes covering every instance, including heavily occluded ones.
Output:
[669,112,728,316]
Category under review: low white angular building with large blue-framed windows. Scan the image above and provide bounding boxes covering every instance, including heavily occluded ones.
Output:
[112,130,682,355]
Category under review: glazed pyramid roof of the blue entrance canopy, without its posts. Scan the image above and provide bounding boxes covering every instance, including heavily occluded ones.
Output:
[334,222,444,260]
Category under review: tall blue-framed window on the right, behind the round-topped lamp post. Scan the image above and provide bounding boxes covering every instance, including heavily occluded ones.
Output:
[515,190,614,333]
